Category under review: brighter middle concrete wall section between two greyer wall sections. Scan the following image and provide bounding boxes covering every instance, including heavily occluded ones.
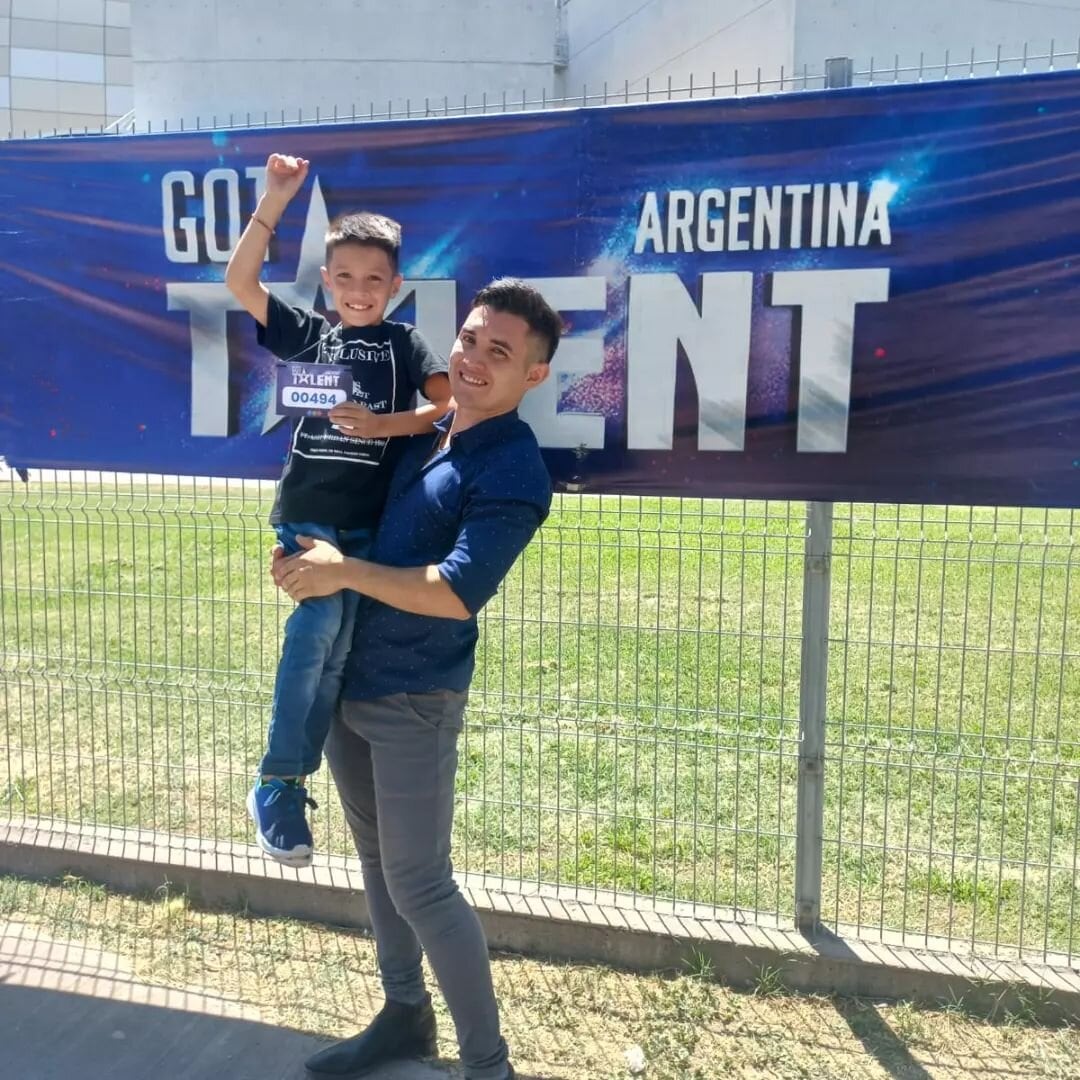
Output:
[557,0,798,96]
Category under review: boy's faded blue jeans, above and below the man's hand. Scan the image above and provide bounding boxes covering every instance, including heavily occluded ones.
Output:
[259,523,343,778]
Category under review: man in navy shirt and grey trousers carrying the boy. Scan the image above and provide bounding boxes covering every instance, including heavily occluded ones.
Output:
[274,280,562,1080]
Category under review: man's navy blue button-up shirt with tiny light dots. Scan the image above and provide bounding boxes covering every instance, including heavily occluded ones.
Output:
[343,411,551,701]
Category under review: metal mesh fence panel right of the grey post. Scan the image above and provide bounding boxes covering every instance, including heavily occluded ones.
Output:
[825,507,1080,956]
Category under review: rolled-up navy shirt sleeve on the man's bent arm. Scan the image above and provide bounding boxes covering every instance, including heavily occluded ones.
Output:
[438,492,546,615]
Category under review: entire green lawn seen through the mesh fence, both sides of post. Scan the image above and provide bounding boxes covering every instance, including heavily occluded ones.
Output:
[0,484,1080,953]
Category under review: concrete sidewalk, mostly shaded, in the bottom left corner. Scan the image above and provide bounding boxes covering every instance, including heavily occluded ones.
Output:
[0,923,448,1080]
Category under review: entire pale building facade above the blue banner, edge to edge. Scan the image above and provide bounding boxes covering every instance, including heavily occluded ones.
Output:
[0,0,1080,136]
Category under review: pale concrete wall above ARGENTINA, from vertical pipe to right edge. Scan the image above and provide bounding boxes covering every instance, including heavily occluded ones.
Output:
[556,0,1080,97]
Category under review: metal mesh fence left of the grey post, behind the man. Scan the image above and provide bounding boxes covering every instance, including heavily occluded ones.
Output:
[0,474,801,915]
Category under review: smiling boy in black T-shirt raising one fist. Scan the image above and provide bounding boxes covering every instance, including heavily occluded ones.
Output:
[225,153,450,866]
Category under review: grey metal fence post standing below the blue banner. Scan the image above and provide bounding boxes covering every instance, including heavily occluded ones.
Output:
[795,502,833,933]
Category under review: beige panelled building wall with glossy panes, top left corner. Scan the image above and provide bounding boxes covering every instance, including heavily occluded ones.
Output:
[0,0,132,138]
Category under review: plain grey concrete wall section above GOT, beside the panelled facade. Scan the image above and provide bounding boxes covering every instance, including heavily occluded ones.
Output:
[132,0,555,124]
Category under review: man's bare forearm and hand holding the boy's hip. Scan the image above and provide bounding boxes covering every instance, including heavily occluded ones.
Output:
[272,537,470,619]
